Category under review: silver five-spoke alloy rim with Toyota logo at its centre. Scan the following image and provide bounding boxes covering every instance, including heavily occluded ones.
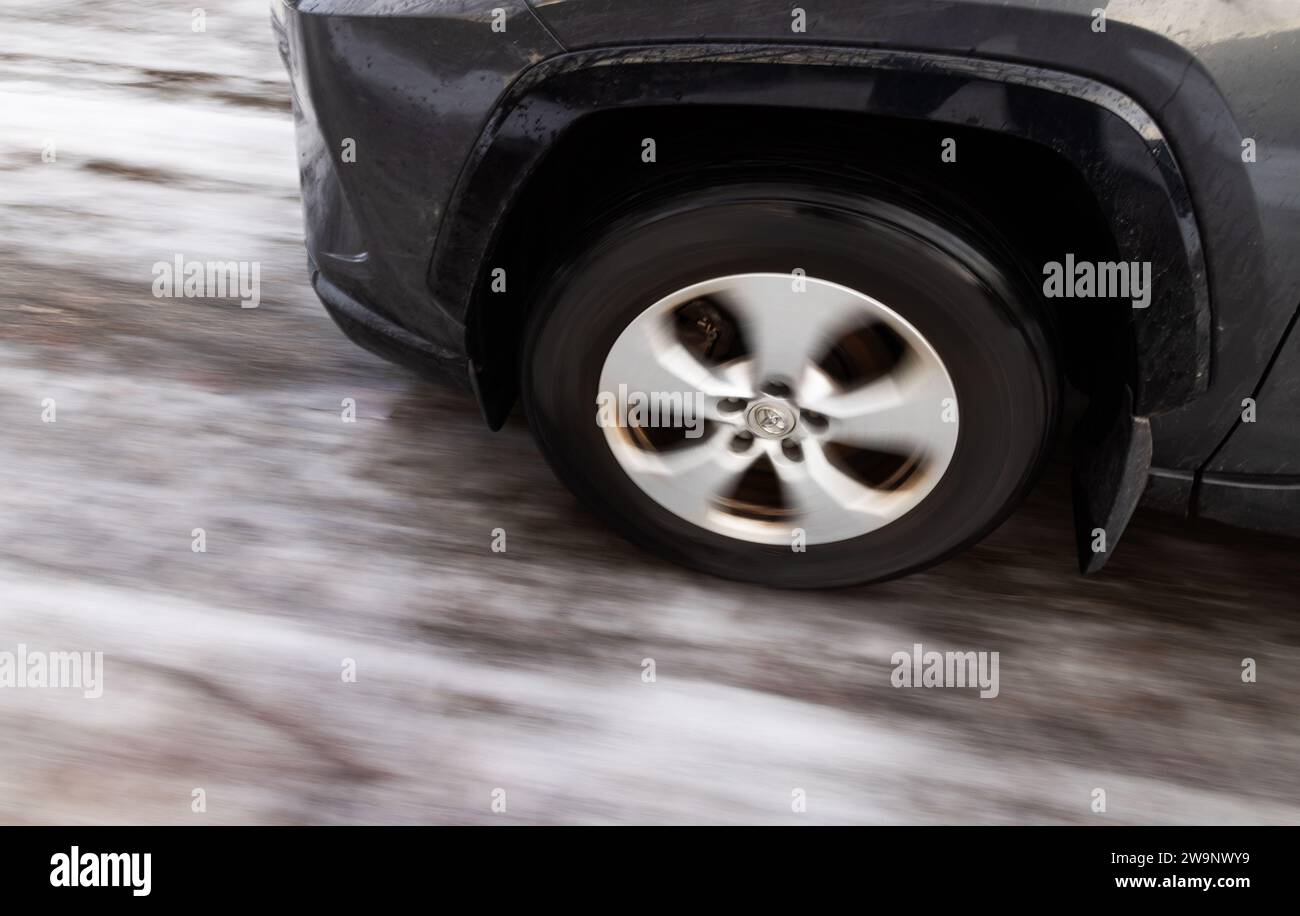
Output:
[598,273,959,546]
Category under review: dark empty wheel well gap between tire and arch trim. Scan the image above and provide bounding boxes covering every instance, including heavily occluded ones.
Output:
[467,107,1135,422]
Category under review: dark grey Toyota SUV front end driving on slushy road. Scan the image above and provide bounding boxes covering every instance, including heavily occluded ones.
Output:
[273,0,1300,586]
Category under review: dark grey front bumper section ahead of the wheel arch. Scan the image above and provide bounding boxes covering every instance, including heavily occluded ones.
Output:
[273,0,560,383]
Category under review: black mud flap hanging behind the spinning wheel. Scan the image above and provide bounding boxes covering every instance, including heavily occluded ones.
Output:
[1073,387,1151,573]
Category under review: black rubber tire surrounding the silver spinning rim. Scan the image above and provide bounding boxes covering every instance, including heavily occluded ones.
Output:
[520,182,1061,589]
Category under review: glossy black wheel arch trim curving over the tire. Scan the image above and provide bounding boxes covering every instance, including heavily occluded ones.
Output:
[429,44,1212,426]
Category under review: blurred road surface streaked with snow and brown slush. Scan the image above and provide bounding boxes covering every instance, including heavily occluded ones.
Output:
[0,0,1300,824]
